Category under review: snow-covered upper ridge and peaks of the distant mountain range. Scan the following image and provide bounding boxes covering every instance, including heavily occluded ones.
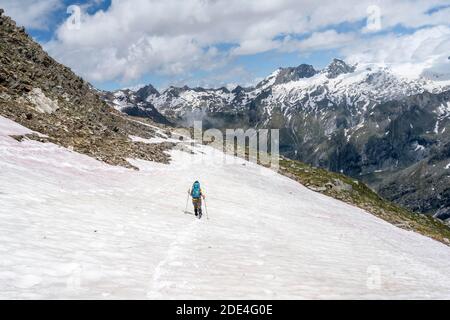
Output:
[147,59,450,120]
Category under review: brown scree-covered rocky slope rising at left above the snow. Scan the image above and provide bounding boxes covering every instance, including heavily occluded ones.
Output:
[0,11,170,167]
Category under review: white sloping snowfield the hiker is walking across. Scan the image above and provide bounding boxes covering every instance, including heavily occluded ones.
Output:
[0,117,450,299]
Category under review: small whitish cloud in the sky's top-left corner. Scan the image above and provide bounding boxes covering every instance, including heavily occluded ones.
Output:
[0,0,62,29]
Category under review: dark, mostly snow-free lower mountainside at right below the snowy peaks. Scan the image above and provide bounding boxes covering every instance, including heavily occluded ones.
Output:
[284,92,450,217]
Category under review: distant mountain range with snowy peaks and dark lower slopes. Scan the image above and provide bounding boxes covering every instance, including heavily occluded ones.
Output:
[107,59,450,219]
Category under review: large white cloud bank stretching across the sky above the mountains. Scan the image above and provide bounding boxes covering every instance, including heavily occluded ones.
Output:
[34,0,448,82]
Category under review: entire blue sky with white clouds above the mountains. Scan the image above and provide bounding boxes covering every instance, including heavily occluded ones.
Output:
[0,0,450,90]
